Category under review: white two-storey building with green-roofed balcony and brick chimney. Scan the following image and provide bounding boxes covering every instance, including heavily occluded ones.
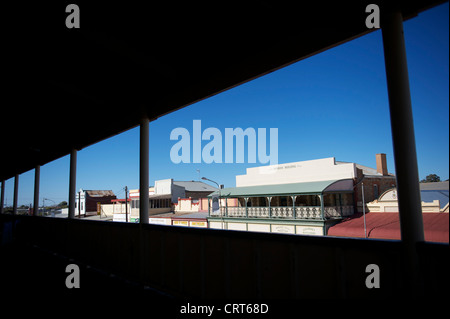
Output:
[208,154,395,235]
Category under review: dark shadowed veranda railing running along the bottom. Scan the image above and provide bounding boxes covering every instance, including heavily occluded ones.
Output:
[0,215,450,299]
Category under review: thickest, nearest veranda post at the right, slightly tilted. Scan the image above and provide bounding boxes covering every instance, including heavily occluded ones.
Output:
[382,10,424,294]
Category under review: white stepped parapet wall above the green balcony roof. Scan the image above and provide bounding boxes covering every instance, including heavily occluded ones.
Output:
[236,157,356,187]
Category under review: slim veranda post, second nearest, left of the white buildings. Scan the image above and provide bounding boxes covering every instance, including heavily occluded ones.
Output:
[139,118,149,224]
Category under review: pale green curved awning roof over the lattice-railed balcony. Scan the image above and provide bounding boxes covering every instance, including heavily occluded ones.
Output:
[208,179,353,197]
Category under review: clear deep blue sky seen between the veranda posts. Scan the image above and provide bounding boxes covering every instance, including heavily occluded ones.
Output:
[5,3,449,205]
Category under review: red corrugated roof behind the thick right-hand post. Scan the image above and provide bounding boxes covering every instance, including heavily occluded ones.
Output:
[328,213,449,243]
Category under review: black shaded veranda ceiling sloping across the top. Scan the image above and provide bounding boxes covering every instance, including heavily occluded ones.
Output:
[0,0,442,180]
